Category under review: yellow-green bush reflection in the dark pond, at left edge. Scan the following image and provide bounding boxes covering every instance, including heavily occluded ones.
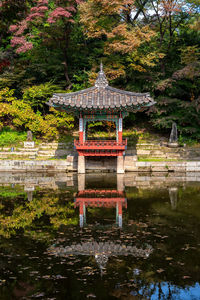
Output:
[0,192,77,237]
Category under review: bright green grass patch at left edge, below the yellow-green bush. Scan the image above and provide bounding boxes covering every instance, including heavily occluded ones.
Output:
[0,128,27,147]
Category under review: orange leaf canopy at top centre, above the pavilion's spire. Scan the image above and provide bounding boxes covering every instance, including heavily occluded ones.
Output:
[79,0,154,61]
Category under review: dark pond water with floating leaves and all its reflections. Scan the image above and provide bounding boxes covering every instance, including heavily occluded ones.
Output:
[0,174,200,300]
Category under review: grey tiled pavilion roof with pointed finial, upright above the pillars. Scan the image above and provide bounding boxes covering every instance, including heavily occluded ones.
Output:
[47,64,155,114]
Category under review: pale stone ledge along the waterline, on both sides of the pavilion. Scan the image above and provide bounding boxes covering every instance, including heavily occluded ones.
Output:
[0,155,200,176]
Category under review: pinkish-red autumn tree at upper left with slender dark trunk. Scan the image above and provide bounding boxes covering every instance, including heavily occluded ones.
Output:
[10,0,80,86]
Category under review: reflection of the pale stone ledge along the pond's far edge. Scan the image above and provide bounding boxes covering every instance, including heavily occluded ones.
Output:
[0,172,200,190]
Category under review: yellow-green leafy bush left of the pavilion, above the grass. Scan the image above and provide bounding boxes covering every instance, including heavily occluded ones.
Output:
[0,88,74,139]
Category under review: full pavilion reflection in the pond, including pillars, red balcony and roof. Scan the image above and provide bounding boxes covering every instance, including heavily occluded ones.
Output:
[48,174,153,275]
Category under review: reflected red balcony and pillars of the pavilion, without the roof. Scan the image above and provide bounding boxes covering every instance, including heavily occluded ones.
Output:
[75,175,127,227]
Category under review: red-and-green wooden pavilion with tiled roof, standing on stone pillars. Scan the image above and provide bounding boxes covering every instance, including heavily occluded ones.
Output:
[47,63,155,174]
